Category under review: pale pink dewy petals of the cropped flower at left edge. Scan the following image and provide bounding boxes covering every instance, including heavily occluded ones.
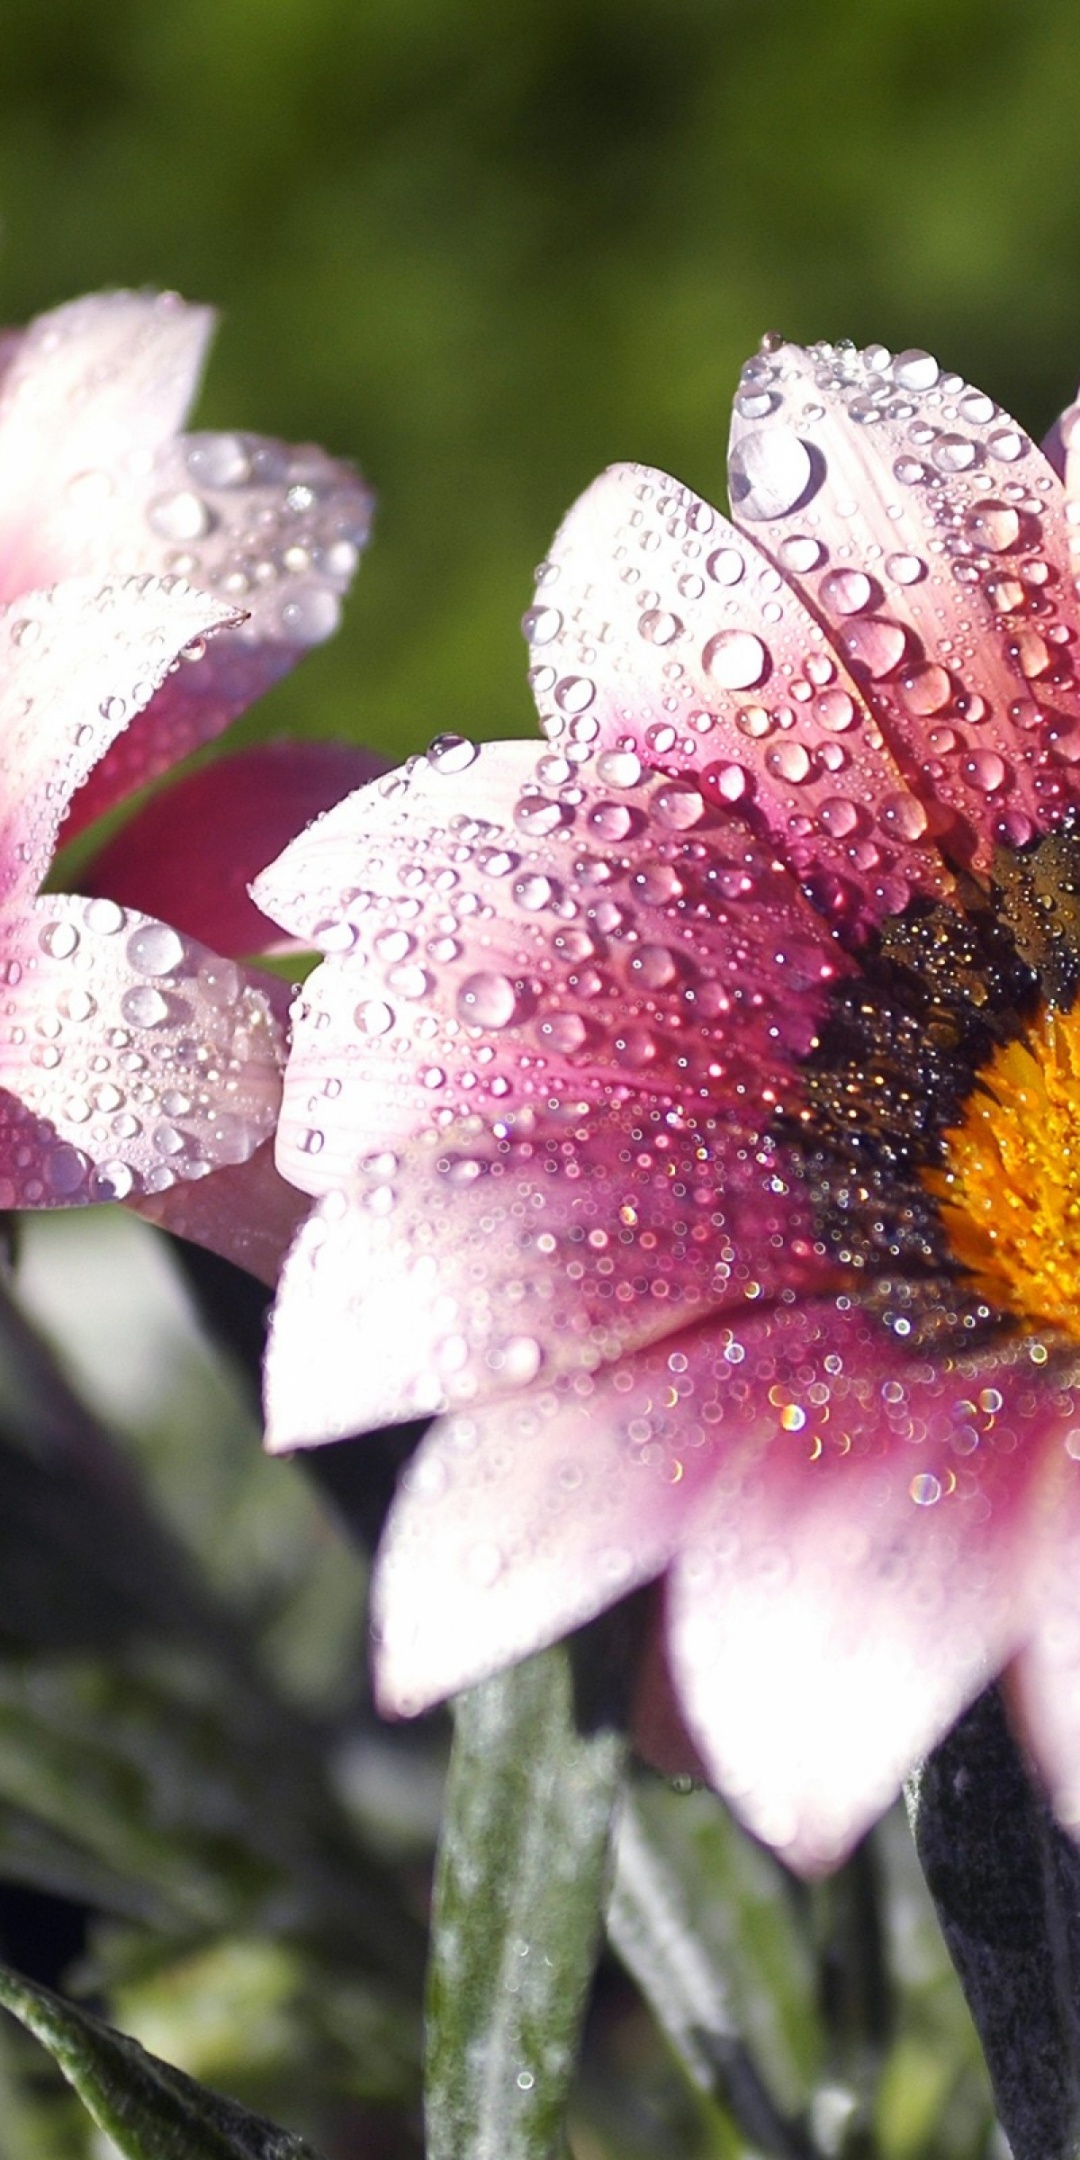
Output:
[0,294,367,1235]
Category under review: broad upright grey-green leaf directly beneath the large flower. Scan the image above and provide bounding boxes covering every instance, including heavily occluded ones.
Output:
[428,1644,624,2160]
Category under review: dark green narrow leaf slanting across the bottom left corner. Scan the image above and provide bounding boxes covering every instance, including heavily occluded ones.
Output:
[0,1966,318,2160]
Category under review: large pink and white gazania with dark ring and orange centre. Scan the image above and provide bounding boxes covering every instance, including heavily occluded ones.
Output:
[257,341,1080,1868]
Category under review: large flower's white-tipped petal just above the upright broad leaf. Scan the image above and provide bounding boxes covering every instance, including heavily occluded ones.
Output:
[372,1335,724,1717]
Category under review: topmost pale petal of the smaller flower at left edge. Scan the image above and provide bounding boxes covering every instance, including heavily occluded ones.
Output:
[0,292,214,600]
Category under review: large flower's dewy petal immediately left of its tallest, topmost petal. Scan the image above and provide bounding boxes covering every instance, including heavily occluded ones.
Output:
[525,464,950,935]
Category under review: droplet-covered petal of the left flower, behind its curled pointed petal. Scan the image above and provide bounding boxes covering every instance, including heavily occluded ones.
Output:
[67,434,372,833]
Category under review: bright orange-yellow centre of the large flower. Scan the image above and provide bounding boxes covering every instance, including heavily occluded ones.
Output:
[922,1004,1080,1339]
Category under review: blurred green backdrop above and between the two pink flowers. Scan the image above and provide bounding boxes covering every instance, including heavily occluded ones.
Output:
[0,0,1080,768]
